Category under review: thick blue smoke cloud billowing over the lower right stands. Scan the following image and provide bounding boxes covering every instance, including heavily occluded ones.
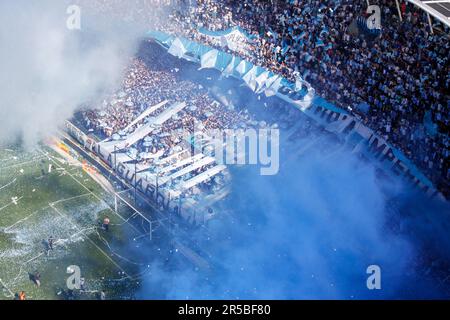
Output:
[140,131,449,299]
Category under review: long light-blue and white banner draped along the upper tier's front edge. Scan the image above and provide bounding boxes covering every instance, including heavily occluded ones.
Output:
[148,32,443,197]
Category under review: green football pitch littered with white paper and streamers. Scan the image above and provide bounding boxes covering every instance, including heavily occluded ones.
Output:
[0,146,162,299]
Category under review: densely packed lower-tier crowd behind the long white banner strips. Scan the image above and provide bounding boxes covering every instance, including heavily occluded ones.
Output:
[82,46,255,161]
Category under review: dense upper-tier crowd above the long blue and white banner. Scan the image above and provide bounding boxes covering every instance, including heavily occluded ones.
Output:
[76,0,450,195]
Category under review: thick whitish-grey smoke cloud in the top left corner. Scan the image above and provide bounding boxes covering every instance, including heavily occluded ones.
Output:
[0,0,138,146]
